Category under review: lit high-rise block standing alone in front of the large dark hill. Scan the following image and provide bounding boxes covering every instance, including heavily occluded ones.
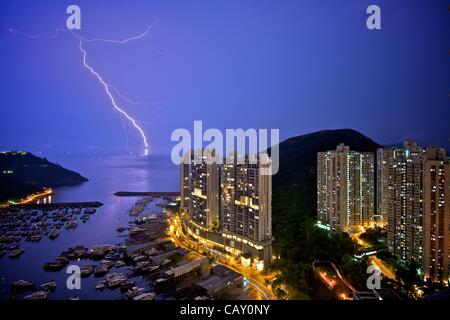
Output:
[317,144,375,232]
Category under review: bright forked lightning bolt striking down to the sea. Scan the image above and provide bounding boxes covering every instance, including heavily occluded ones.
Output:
[3,23,156,155]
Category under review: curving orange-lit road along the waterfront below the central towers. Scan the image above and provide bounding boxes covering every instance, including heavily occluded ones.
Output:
[171,212,276,300]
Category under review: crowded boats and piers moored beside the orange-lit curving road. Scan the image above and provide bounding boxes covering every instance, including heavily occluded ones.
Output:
[2,192,260,300]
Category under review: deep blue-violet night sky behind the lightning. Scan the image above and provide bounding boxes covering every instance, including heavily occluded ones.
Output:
[0,0,450,153]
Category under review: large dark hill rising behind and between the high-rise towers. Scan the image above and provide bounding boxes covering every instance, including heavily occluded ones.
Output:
[272,129,382,245]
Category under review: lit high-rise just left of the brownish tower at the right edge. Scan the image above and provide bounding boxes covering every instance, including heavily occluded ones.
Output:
[377,141,423,264]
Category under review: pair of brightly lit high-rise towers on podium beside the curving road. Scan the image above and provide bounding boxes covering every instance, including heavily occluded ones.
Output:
[181,153,272,270]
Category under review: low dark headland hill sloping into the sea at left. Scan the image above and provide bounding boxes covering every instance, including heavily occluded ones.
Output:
[0,151,88,201]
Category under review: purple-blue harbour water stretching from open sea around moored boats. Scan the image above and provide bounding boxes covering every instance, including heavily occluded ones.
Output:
[0,155,179,299]
